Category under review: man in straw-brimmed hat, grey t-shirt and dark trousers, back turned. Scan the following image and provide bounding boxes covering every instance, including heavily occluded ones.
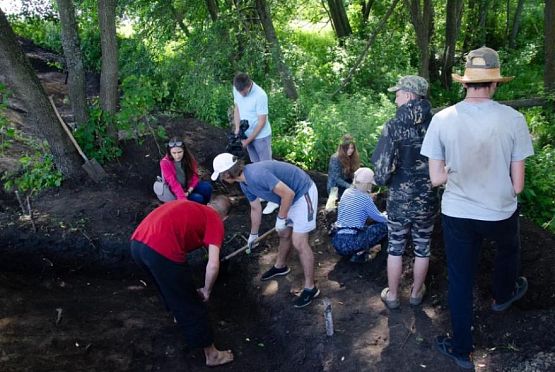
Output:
[421,47,533,369]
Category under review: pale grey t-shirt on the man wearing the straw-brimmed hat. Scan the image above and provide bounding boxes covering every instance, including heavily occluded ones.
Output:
[420,101,534,221]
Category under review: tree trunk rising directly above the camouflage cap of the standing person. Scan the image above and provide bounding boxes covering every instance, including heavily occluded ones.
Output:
[405,0,434,80]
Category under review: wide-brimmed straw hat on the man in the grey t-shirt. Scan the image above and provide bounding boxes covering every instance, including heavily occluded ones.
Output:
[451,47,514,83]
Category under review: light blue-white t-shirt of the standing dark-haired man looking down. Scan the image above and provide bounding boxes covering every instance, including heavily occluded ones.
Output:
[233,81,272,139]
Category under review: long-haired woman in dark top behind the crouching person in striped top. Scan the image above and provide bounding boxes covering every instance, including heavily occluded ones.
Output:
[327,134,360,198]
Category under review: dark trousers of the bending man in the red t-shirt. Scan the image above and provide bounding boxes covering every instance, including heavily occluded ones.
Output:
[131,240,214,348]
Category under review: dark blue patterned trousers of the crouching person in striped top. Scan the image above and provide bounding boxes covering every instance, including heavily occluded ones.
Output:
[331,222,387,256]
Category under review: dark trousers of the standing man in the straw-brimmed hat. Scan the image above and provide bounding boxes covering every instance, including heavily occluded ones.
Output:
[442,210,520,354]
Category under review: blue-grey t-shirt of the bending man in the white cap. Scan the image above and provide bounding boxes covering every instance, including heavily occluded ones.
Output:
[240,160,313,204]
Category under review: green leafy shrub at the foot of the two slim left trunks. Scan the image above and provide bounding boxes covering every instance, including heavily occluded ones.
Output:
[74,101,122,164]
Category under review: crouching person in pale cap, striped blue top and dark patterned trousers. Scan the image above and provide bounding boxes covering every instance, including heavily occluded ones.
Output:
[331,168,387,262]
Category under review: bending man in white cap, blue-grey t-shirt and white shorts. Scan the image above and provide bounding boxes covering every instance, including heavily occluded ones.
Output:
[212,153,320,308]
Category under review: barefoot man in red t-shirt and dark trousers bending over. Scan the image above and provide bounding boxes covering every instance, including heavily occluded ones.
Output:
[131,195,233,366]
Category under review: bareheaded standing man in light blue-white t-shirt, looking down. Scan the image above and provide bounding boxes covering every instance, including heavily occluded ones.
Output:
[233,72,279,214]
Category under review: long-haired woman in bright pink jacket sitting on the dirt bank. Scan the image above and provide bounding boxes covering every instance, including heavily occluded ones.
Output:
[160,137,212,204]
